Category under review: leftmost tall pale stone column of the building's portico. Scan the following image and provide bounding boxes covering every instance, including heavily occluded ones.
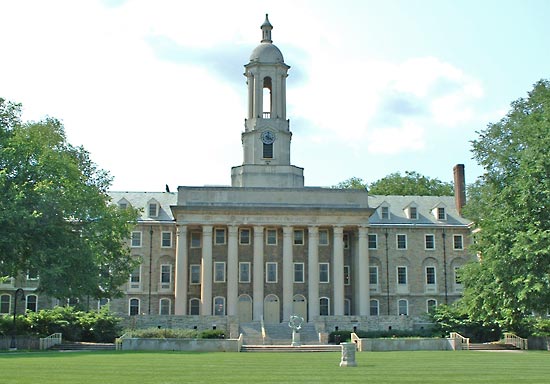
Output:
[174,225,188,315]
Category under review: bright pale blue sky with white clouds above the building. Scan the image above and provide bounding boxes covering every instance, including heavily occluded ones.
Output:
[0,0,550,192]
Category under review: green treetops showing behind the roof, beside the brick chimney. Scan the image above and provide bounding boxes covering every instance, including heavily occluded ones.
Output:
[333,171,453,196]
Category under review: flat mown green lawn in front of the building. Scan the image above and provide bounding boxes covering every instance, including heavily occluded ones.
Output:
[0,351,550,384]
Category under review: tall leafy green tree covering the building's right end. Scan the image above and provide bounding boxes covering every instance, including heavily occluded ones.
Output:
[462,80,550,330]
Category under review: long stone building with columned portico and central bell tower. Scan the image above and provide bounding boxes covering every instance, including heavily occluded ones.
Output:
[0,16,472,327]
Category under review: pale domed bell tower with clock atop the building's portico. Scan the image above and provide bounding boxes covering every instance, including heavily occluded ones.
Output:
[231,15,304,188]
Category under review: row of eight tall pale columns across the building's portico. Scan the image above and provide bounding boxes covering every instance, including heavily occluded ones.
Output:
[174,225,370,320]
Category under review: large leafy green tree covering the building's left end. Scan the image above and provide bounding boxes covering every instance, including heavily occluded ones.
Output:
[0,99,137,298]
